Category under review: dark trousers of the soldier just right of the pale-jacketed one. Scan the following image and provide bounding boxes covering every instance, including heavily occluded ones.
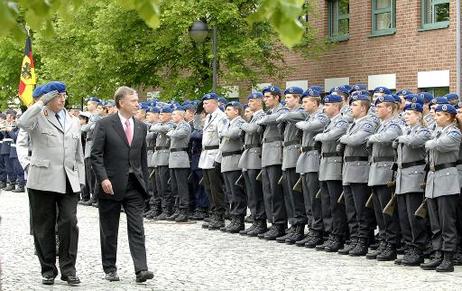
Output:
[223,171,247,217]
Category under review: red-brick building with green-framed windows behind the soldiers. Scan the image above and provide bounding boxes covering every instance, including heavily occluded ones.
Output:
[226,0,462,97]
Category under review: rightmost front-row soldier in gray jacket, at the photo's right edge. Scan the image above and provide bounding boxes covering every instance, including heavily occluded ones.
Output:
[420,104,461,272]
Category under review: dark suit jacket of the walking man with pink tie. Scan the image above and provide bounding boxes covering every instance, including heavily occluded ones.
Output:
[90,113,149,201]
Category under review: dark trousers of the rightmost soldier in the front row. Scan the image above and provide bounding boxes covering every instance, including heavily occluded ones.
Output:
[427,194,459,252]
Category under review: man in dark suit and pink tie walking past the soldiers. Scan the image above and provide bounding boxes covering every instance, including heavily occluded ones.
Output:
[90,86,154,283]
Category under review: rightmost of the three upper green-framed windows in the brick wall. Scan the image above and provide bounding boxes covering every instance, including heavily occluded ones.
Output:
[421,0,449,30]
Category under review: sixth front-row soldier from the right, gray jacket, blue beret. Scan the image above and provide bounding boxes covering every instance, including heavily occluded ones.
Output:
[295,88,330,248]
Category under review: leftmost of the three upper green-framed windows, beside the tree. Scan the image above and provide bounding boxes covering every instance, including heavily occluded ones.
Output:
[328,0,350,41]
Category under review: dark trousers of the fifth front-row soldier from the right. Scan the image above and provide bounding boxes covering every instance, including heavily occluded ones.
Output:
[326,180,347,239]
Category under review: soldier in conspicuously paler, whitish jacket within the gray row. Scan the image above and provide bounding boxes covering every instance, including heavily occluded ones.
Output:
[199,93,226,230]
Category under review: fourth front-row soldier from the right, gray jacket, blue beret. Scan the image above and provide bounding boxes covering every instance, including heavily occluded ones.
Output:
[340,94,376,256]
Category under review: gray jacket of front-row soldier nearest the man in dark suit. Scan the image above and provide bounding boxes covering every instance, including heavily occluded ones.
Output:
[150,122,175,168]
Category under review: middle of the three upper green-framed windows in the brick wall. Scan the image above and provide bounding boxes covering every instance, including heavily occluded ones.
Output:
[372,0,396,36]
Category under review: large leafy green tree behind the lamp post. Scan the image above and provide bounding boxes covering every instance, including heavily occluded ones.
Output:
[35,0,322,103]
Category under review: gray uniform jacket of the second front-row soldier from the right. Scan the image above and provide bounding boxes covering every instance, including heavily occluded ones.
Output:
[395,125,431,194]
